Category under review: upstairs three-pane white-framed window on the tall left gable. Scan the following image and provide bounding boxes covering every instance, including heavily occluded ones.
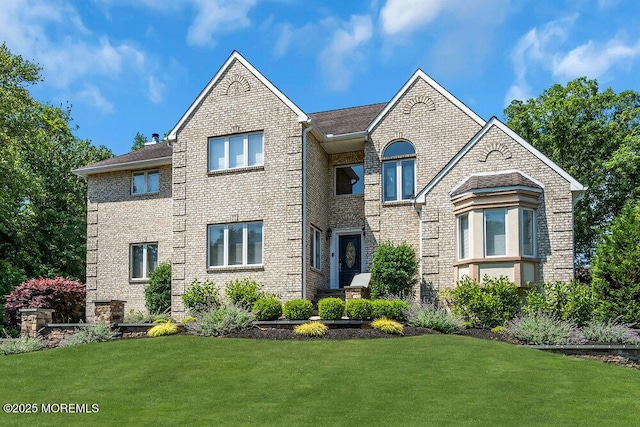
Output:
[208,132,264,172]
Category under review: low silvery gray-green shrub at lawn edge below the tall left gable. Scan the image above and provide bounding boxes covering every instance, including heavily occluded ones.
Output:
[188,304,253,337]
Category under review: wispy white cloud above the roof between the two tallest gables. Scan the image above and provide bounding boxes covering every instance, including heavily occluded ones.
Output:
[318,15,373,91]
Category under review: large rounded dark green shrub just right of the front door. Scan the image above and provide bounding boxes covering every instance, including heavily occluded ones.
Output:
[371,242,418,298]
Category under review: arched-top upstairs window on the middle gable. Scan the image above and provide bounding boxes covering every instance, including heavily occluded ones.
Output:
[382,141,416,202]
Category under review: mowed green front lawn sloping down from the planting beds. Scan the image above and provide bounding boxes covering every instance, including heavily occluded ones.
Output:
[0,335,640,426]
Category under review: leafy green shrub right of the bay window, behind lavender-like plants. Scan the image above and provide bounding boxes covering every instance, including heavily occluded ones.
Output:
[522,281,599,326]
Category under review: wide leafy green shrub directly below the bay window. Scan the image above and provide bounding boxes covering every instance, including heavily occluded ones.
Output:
[441,276,520,328]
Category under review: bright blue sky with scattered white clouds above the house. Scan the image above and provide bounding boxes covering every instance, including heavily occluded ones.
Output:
[0,0,640,154]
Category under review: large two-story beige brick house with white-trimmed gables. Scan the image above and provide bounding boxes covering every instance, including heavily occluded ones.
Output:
[75,52,584,317]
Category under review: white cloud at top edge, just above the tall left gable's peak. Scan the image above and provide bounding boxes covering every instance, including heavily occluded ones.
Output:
[187,0,257,46]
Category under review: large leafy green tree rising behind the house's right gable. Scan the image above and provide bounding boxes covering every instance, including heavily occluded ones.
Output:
[505,78,640,264]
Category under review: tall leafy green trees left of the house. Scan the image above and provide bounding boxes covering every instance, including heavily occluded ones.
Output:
[0,44,112,295]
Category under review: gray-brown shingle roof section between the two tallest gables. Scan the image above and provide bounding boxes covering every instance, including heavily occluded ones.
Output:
[309,102,387,135]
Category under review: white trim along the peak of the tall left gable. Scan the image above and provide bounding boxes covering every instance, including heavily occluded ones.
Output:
[167,50,308,140]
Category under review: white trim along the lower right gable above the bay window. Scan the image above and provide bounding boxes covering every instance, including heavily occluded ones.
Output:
[414,117,586,204]
